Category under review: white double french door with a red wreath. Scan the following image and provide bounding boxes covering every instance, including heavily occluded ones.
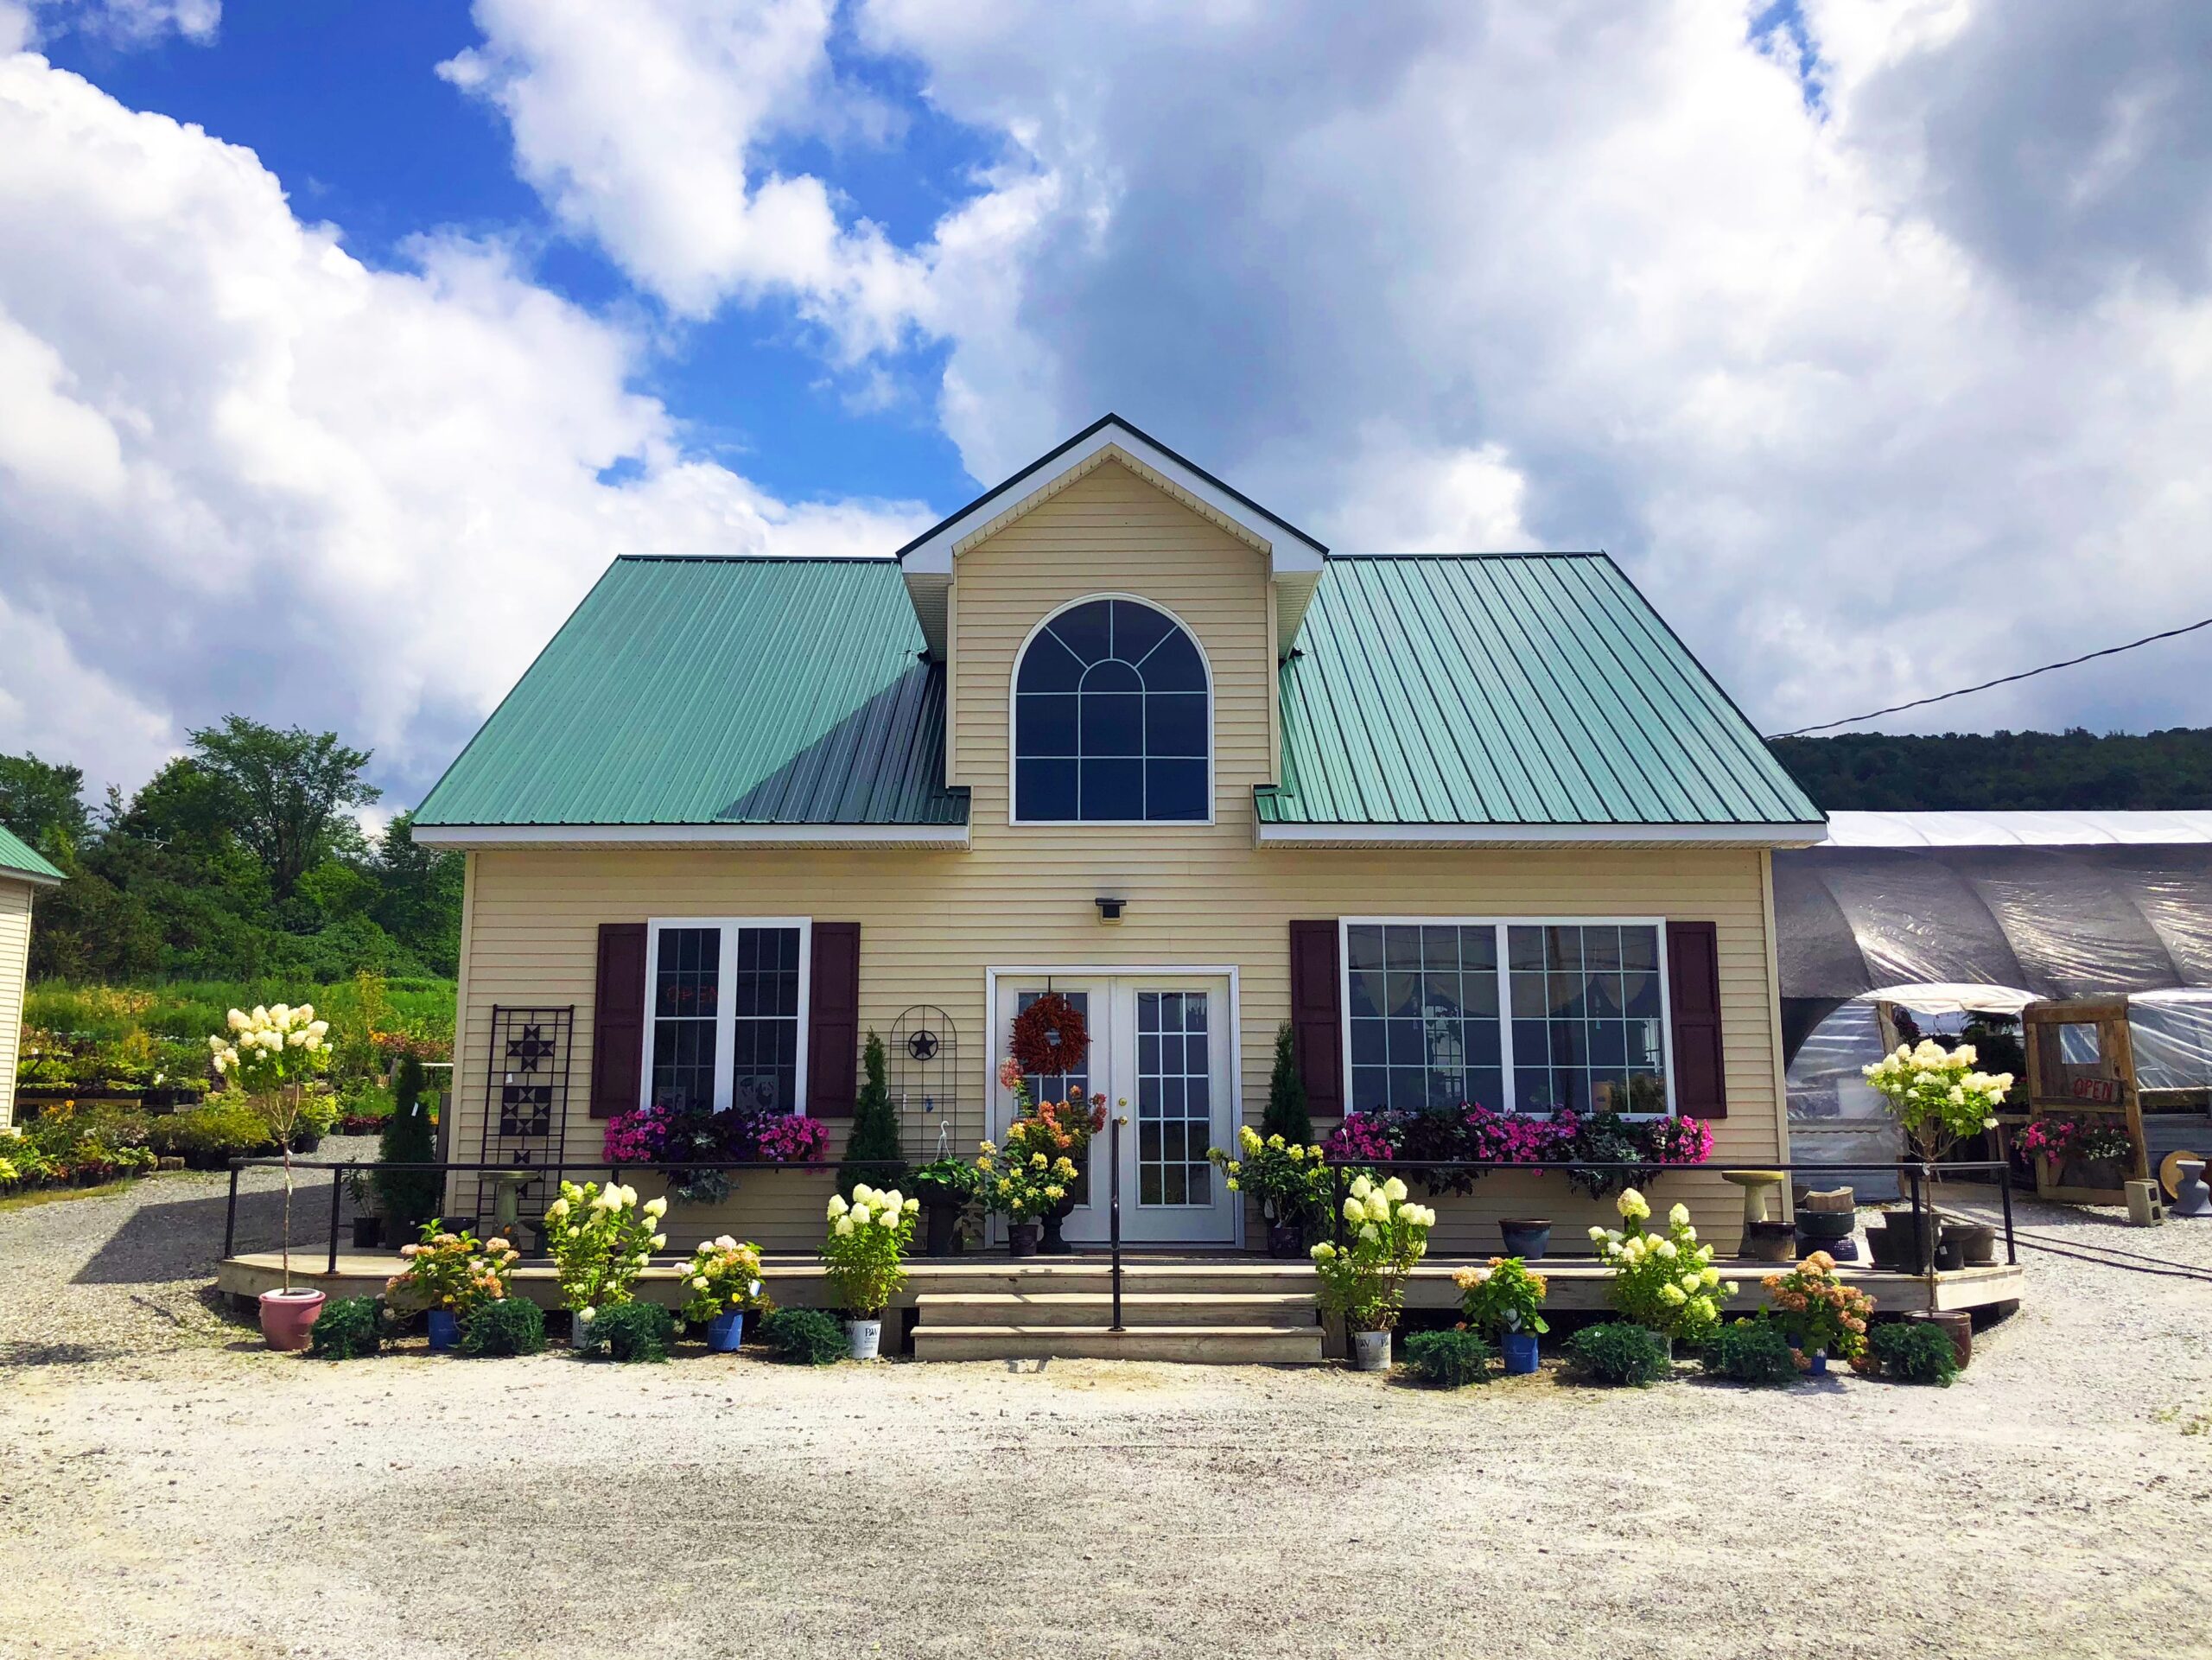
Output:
[991,971,1236,1243]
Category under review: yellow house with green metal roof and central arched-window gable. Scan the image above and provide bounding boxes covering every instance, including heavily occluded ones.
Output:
[416,417,1821,1253]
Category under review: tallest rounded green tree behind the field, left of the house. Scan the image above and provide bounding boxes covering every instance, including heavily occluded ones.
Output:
[193,715,383,906]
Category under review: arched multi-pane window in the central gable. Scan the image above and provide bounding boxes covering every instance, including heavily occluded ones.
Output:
[1013,600,1212,824]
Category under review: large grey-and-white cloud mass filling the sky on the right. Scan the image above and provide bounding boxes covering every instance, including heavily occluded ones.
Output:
[840,0,2212,726]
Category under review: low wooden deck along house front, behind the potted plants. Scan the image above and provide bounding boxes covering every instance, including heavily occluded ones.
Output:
[214,1250,2026,1314]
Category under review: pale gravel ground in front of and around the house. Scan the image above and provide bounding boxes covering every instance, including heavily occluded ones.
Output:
[0,1175,2212,1660]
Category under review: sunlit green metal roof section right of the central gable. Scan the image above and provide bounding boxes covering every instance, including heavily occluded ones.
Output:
[1256,553,1821,825]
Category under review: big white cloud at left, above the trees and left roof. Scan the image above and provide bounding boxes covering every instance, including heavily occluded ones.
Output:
[0,53,929,799]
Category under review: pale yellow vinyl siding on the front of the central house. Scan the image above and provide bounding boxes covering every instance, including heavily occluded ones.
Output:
[451,462,1783,1250]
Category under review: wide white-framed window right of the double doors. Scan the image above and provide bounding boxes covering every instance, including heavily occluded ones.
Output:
[1338,916,1675,1116]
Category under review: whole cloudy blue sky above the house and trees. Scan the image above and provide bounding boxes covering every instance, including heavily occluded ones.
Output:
[0,0,2212,804]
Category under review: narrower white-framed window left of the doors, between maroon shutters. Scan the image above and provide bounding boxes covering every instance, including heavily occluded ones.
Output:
[644,916,814,1116]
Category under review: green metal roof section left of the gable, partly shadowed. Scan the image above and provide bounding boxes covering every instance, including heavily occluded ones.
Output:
[416,557,967,828]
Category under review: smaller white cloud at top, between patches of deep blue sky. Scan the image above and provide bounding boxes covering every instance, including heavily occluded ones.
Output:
[440,0,927,359]
